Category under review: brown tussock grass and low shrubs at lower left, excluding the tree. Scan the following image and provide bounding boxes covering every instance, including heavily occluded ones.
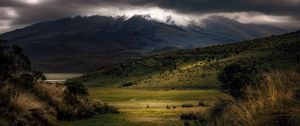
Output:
[0,82,118,126]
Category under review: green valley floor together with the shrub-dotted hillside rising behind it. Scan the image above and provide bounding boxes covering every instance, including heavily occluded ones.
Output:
[56,32,300,126]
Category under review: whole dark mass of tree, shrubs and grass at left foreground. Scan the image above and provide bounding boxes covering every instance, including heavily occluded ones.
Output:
[0,40,118,126]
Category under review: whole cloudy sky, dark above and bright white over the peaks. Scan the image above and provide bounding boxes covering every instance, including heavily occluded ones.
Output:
[0,0,300,33]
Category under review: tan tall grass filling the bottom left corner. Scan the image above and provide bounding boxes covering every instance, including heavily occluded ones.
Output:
[0,84,57,126]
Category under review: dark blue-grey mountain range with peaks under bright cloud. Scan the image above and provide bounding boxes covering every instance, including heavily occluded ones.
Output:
[0,15,285,72]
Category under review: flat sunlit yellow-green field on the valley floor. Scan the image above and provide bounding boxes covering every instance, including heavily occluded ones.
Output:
[60,88,225,126]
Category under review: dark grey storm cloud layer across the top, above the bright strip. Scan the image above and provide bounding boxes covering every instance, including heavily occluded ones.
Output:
[0,0,300,32]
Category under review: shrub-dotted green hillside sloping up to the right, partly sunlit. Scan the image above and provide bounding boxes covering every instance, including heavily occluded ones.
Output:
[76,31,300,88]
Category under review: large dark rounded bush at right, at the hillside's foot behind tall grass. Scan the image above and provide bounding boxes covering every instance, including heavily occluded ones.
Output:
[218,62,262,98]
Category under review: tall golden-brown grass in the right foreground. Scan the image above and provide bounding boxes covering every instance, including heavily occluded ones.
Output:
[204,71,300,126]
